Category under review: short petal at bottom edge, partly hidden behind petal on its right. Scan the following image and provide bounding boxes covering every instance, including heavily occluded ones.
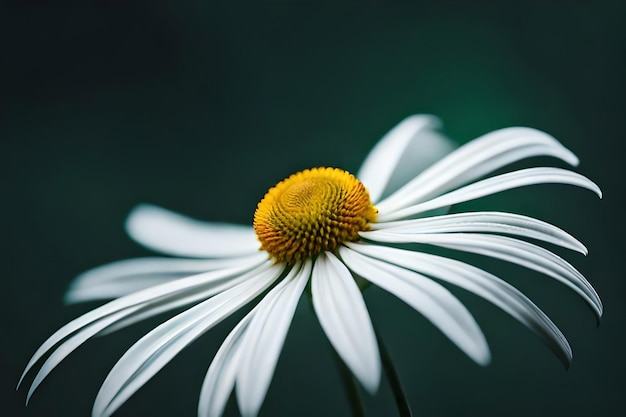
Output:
[198,305,252,417]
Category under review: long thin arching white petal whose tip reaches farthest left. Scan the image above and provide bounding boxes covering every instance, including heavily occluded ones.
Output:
[18,257,271,387]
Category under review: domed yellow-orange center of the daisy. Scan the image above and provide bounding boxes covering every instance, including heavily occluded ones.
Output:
[254,168,377,264]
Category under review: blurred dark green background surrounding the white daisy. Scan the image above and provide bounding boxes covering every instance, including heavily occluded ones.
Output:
[0,0,626,417]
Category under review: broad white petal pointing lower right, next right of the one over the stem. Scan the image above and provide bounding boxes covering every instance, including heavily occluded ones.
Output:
[339,246,491,365]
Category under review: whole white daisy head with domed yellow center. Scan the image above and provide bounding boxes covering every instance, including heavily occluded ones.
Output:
[20,115,602,417]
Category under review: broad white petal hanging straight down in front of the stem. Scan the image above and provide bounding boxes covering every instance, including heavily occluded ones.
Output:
[311,252,381,394]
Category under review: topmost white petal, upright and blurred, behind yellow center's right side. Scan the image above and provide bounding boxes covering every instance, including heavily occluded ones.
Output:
[357,115,454,202]
